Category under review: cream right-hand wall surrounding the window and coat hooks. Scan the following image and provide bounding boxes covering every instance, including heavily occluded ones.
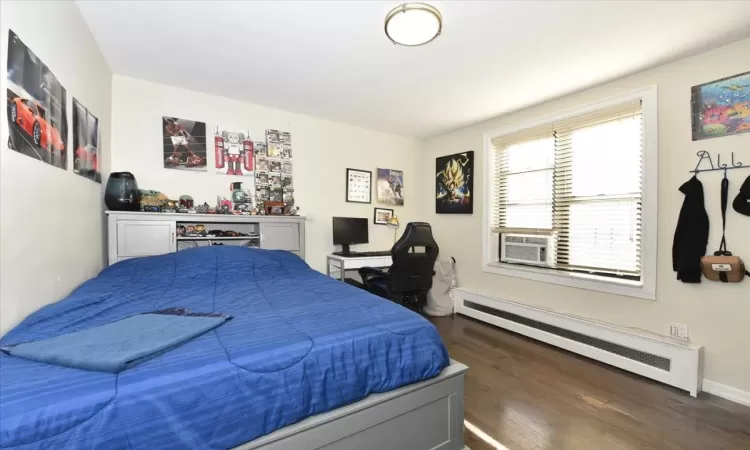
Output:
[422,36,750,391]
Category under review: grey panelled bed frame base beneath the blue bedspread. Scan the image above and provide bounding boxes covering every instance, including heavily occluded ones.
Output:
[234,360,468,450]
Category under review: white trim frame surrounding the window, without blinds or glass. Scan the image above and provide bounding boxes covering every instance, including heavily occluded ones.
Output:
[482,85,659,300]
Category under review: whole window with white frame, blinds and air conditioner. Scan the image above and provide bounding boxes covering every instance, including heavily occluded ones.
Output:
[484,88,656,298]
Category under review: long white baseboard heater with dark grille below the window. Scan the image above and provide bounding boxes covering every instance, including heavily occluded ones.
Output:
[454,288,703,397]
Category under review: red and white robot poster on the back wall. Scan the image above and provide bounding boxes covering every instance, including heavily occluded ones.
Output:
[214,126,255,178]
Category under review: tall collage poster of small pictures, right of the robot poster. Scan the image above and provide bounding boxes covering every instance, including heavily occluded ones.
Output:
[255,130,294,205]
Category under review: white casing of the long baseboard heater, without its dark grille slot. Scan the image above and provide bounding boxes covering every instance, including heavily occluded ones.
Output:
[454,288,703,397]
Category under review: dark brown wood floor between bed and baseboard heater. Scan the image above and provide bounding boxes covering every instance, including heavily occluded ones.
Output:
[430,316,750,450]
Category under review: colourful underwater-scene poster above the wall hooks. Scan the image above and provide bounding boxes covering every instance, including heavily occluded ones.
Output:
[691,72,750,141]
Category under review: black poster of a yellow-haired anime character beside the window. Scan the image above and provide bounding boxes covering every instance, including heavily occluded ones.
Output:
[435,151,474,214]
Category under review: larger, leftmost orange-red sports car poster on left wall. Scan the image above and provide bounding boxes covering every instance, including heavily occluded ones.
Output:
[7,30,68,170]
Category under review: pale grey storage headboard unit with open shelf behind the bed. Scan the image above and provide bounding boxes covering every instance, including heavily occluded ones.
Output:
[106,211,305,265]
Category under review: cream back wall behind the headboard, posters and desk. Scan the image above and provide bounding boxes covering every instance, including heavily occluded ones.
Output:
[112,75,422,271]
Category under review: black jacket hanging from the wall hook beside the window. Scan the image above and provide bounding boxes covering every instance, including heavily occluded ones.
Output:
[672,176,708,283]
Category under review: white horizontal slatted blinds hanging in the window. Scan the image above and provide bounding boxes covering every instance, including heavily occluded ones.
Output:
[491,101,643,278]
